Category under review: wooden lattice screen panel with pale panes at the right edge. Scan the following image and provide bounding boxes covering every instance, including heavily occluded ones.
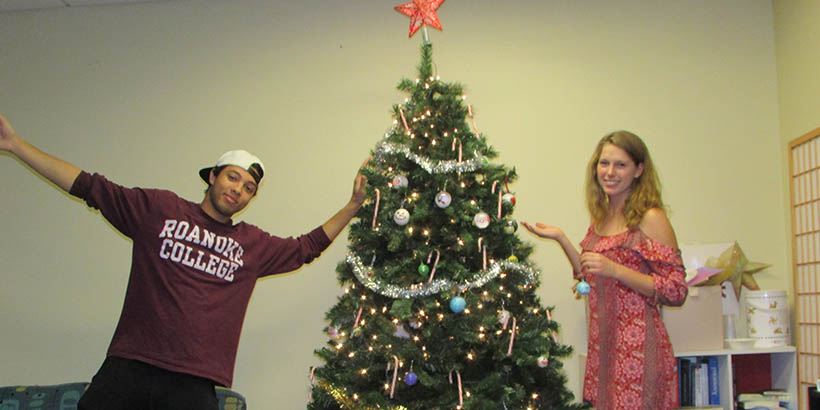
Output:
[789,128,820,410]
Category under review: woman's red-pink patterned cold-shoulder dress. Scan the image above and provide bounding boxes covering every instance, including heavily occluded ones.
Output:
[581,226,687,410]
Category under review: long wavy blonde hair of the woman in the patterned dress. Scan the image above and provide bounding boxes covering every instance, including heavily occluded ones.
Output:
[586,130,664,229]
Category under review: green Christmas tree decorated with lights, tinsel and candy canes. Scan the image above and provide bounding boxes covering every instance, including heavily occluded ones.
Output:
[308,7,584,410]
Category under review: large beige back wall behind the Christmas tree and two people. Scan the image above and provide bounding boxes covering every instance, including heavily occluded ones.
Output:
[0,0,788,409]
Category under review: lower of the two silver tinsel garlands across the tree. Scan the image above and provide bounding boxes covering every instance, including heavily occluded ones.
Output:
[345,253,540,299]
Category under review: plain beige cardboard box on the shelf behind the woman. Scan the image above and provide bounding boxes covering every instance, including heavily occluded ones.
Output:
[661,286,725,354]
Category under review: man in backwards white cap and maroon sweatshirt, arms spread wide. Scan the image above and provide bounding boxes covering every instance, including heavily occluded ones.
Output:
[0,116,367,410]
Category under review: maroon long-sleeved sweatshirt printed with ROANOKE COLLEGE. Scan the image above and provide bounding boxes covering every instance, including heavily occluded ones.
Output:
[70,172,330,387]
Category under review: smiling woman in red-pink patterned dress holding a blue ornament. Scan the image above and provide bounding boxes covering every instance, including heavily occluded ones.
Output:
[522,131,687,410]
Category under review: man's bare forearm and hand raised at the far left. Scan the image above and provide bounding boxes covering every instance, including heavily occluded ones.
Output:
[0,115,81,192]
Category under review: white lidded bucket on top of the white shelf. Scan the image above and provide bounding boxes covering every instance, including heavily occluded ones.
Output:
[746,290,791,347]
